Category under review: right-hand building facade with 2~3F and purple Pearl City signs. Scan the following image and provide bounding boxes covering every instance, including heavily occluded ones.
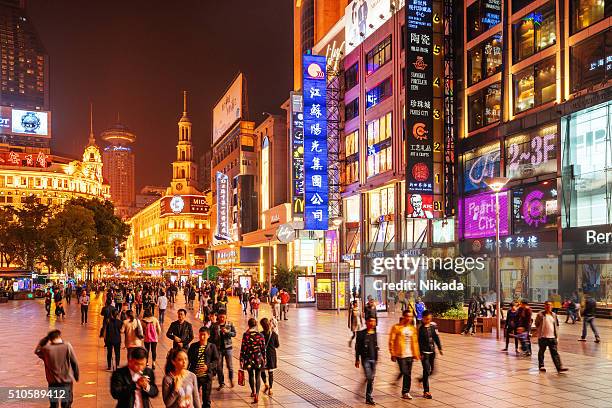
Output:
[458,0,612,302]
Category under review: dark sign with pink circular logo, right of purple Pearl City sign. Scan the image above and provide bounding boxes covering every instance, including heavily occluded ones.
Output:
[512,181,559,234]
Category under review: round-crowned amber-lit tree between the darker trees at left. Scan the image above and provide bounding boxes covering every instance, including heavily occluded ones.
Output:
[45,203,96,275]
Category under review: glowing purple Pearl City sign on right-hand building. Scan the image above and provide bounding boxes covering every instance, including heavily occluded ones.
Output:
[460,191,509,238]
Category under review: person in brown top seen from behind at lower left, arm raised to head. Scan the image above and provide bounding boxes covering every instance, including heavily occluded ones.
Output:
[34,330,79,408]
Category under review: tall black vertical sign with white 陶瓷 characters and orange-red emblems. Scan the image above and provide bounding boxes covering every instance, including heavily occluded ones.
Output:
[405,0,440,195]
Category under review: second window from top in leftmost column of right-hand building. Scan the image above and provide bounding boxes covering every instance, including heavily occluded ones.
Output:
[468,34,502,86]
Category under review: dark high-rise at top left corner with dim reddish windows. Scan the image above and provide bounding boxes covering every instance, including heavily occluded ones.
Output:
[0,0,49,110]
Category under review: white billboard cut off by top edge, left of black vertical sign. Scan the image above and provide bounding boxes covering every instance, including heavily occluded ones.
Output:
[344,0,393,54]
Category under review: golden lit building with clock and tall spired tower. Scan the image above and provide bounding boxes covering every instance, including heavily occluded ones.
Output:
[124,92,210,276]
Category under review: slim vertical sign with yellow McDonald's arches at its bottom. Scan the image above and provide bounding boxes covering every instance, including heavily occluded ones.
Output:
[290,92,304,214]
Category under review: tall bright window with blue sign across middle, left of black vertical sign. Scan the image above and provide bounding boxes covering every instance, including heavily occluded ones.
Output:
[367,112,392,177]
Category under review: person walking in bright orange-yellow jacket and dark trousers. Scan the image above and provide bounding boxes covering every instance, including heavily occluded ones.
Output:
[389,310,420,399]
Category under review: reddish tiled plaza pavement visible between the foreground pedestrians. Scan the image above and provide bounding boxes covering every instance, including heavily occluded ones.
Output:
[0,296,612,408]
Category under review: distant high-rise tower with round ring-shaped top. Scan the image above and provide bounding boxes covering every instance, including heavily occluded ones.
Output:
[100,119,136,217]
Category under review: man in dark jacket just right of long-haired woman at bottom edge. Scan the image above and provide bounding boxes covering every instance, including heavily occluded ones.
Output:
[187,326,219,408]
